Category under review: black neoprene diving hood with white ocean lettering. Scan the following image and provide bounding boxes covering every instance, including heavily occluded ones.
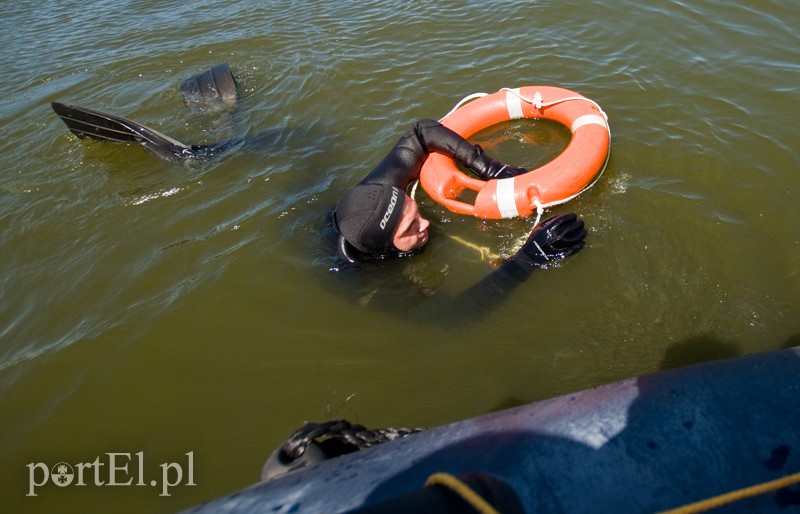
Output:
[333,184,406,255]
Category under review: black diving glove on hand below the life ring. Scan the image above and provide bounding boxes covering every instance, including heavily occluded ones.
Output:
[509,213,586,268]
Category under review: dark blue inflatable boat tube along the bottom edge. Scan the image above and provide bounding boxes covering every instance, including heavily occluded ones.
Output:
[186,347,800,514]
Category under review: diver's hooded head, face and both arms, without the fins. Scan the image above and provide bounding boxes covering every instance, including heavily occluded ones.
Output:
[333,120,586,298]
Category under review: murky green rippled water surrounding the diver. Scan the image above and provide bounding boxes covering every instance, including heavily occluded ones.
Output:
[0,0,800,512]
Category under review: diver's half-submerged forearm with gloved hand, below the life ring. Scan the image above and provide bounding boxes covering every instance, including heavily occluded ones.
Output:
[455,213,586,317]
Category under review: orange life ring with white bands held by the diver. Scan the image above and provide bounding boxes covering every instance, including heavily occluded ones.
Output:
[420,86,611,219]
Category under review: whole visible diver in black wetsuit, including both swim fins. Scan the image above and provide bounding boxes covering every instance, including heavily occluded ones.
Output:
[52,64,586,299]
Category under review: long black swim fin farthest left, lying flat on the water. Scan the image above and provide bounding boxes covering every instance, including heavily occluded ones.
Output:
[52,102,194,162]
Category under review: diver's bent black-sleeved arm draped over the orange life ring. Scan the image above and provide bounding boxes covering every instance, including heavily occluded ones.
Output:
[361,120,520,189]
